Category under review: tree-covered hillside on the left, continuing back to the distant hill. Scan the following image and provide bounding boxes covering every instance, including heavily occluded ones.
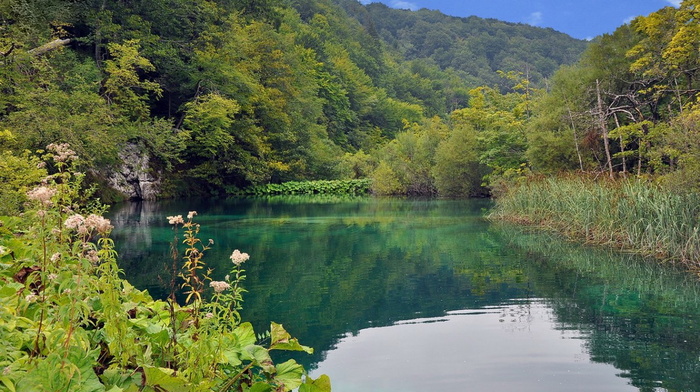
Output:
[0,0,585,206]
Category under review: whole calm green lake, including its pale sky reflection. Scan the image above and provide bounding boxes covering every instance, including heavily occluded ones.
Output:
[106,197,700,392]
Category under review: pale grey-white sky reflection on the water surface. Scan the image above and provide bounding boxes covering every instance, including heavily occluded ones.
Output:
[316,300,635,392]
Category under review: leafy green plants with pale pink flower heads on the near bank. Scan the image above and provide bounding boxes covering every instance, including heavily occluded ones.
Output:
[0,144,330,392]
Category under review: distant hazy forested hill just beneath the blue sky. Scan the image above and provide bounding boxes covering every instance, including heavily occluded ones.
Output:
[336,0,587,88]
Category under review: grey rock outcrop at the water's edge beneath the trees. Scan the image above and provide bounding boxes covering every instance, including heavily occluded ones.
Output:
[107,143,161,200]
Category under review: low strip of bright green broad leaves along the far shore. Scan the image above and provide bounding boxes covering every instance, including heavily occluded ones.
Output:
[242,179,372,196]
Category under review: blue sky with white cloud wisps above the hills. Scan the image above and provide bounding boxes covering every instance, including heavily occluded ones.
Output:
[360,0,681,39]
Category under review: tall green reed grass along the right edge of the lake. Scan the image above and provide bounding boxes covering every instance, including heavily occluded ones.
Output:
[491,176,700,271]
